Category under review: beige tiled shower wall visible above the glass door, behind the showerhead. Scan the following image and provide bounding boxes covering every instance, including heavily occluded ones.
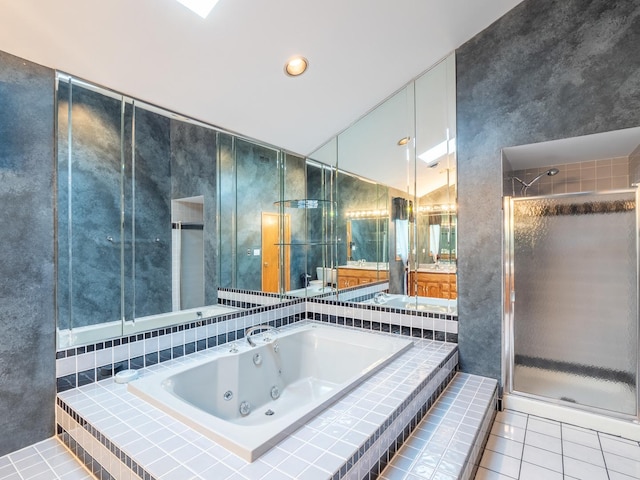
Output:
[504,157,631,197]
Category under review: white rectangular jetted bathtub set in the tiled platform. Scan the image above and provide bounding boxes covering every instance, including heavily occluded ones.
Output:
[128,322,413,462]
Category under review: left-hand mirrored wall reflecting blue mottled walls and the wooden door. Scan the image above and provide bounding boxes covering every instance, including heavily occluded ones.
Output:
[57,74,335,348]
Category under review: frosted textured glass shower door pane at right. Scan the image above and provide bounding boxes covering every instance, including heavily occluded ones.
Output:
[509,191,638,416]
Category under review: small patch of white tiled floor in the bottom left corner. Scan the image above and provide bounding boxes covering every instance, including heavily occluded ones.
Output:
[0,437,95,480]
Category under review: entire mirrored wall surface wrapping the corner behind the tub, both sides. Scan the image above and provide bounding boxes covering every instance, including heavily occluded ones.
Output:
[57,52,456,348]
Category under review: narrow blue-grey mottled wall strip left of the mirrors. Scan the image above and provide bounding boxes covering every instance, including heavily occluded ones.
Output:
[0,52,55,455]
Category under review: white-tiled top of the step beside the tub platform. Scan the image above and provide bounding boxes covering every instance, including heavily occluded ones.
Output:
[379,373,497,480]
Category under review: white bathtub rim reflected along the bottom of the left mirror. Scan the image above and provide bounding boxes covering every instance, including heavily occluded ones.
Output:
[57,305,238,350]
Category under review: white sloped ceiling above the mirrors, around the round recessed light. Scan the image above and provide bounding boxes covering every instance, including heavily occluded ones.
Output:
[0,0,521,155]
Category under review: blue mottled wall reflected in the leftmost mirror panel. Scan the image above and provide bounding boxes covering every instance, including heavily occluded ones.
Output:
[58,82,121,328]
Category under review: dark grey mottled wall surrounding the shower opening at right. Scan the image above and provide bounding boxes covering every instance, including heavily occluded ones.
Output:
[456,0,640,378]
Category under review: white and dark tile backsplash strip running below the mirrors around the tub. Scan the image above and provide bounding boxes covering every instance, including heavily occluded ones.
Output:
[56,289,458,392]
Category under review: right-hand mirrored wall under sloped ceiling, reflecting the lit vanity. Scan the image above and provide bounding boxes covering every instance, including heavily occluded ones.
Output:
[311,55,457,313]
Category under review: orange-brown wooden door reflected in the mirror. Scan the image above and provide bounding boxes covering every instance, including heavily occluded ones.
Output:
[262,212,291,293]
